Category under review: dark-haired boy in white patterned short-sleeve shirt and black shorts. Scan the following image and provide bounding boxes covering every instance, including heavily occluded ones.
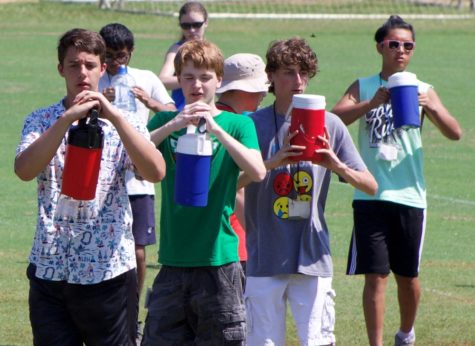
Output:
[15,29,165,345]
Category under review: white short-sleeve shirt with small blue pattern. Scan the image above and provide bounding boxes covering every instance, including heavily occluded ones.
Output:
[17,101,148,284]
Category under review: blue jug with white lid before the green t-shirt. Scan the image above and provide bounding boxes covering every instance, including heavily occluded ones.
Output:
[175,121,213,207]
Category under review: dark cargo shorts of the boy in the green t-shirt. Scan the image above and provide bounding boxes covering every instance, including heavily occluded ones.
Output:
[142,262,246,346]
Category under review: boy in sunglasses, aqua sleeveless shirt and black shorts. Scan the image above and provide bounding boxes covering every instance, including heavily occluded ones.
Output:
[333,16,462,346]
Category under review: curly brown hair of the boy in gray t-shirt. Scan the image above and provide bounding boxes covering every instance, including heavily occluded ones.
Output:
[266,37,318,93]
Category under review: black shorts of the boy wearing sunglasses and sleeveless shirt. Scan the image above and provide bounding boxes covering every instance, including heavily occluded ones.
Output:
[346,200,426,277]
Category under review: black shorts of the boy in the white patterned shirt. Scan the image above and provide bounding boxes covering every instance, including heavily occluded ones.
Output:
[27,264,138,346]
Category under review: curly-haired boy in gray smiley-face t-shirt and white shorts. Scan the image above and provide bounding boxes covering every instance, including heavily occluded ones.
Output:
[239,38,377,346]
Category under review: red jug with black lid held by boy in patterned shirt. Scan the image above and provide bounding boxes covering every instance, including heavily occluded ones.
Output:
[61,108,104,201]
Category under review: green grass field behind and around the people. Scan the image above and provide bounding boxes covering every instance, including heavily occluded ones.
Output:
[0,3,475,345]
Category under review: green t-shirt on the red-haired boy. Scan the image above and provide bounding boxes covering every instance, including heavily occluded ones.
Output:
[148,112,259,267]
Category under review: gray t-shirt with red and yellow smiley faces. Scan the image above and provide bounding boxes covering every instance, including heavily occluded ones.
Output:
[245,106,366,277]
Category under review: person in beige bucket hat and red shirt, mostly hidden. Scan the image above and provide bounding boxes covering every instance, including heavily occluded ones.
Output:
[216,53,269,272]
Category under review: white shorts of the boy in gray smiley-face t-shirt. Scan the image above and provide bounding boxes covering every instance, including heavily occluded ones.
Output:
[244,274,335,346]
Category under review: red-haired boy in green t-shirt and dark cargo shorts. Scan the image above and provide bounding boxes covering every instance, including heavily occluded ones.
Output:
[142,41,266,345]
